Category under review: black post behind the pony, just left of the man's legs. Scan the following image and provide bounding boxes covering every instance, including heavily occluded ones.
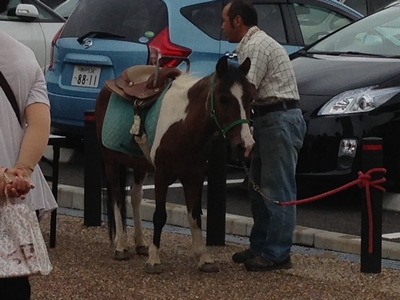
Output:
[206,135,227,246]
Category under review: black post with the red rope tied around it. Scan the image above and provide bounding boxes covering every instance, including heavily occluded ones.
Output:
[361,137,383,273]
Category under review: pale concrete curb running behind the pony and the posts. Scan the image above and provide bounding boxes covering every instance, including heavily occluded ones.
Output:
[58,185,400,260]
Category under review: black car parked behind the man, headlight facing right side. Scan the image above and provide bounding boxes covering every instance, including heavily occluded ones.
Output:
[291,2,400,192]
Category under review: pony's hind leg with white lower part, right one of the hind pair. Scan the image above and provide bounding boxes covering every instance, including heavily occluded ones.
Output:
[131,170,149,255]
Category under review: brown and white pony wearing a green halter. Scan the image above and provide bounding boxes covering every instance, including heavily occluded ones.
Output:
[95,57,255,273]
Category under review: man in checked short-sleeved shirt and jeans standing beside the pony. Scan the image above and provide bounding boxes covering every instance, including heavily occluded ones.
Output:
[222,0,306,271]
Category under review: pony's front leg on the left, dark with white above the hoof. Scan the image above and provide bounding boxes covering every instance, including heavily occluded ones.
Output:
[145,170,168,274]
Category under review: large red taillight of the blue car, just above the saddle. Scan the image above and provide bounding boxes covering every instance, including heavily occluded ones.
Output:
[148,27,192,67]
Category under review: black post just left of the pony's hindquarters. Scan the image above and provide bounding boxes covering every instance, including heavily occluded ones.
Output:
[83,111,102,226]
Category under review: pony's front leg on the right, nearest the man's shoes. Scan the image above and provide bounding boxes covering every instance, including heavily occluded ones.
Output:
[181,173,219,272]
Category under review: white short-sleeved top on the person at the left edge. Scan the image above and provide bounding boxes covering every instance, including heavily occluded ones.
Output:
[0,31,57,212]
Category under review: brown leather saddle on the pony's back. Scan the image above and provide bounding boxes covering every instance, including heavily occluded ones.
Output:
[105,65,181,109]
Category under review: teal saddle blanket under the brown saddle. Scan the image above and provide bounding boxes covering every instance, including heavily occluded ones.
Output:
[101,84,170,156]
